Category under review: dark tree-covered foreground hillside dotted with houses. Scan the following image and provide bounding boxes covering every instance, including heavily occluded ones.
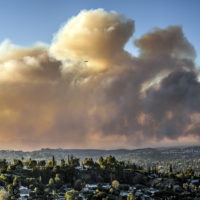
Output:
[0,155,200,200]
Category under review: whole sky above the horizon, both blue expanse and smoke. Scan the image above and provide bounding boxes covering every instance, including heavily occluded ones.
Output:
[0,0,200,150]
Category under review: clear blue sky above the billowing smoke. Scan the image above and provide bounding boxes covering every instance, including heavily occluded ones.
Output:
[0,0,200,66]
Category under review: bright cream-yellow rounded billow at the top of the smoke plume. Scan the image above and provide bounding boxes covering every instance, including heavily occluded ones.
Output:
[50,9,134,69]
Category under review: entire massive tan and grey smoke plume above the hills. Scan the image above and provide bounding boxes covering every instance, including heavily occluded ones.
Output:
[0,9,200,149]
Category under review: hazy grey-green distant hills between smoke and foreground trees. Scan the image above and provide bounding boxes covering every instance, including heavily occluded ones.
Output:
[0,146,200,175]
